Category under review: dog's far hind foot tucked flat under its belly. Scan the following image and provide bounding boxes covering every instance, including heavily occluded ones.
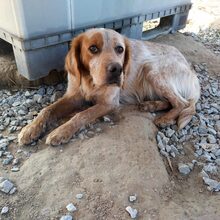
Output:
[139,101,171,112]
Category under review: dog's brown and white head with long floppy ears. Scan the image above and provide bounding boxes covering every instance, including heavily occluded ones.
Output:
[65,28,130,86]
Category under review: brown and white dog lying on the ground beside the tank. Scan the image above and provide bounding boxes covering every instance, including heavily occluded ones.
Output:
[18,28,200,145]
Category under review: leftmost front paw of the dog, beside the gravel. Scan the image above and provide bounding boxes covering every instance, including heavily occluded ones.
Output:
[18,121,45,145]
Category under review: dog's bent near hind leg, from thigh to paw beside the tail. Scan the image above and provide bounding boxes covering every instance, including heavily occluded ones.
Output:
[148,73,188,127]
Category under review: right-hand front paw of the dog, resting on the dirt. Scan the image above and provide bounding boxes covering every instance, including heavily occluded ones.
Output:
[46,125,74,146]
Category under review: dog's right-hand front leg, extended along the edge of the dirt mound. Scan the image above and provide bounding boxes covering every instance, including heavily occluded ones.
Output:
[46,104,114,146]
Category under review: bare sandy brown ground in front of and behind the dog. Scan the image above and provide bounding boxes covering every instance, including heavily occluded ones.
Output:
[0,1,220,220]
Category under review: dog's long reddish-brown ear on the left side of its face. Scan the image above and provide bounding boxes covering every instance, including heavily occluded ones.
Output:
[65,34,84,87]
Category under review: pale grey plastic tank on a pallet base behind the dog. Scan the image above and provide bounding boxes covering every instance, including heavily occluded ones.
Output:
[0,0,191,80]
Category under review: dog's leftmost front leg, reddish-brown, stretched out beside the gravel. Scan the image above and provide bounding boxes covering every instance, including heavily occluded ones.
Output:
[18,94,83,145]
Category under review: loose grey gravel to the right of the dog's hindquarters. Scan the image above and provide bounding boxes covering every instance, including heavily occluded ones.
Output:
[156,63,220,191]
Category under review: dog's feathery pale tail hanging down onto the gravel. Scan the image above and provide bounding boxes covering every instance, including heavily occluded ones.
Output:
[177,99,196,130]
